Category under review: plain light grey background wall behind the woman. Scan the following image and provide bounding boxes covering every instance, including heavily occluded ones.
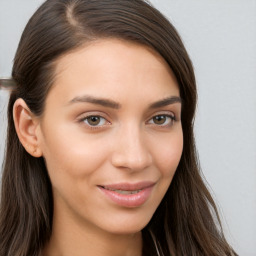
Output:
[0,0,256,256]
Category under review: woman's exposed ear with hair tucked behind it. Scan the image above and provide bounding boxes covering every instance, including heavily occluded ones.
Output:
[13,99,42,157]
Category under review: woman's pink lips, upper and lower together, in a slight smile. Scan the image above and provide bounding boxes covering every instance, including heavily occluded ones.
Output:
[98,181,155,208]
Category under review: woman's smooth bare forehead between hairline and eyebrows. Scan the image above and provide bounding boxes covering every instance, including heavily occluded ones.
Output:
[48,39,179,106]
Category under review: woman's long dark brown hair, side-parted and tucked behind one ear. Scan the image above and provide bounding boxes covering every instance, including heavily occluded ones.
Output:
[0,0,236,256]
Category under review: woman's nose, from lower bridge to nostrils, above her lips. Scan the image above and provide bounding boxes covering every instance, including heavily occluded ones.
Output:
[112,124,152,171]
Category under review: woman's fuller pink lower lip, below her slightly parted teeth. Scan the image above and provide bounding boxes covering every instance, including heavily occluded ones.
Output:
[99,186,153,208]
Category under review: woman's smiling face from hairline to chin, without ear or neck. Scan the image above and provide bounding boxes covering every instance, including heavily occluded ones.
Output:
[38,39,183,234]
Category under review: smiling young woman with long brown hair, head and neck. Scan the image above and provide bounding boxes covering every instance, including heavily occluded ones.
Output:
[0,0,236,256]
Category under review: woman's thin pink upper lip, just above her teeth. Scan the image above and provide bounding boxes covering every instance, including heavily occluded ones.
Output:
[99,181,155,191]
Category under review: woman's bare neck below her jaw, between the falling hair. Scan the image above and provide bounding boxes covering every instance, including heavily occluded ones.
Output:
[42,209,142,256]
